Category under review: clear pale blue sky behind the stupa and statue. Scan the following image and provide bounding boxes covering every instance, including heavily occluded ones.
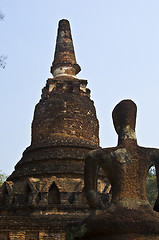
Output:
[0,0,159,175]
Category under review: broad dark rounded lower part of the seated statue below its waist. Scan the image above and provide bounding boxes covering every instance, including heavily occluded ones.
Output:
[70,204,159,240]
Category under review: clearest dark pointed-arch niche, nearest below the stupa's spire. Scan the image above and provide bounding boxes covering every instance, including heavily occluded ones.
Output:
[48,182,60,204]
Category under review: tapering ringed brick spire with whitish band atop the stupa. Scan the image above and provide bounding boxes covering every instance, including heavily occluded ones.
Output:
[51,19,81,77]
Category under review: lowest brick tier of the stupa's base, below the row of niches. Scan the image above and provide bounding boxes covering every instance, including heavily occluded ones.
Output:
[0,208,88,240]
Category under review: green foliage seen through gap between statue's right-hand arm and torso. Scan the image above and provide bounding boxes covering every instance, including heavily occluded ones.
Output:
[146,167,158,207]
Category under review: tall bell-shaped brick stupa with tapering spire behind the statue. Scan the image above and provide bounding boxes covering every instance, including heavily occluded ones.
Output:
[0,20,106,240]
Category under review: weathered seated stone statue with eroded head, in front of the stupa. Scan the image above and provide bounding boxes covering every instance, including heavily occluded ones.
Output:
[73,100,159,240]
